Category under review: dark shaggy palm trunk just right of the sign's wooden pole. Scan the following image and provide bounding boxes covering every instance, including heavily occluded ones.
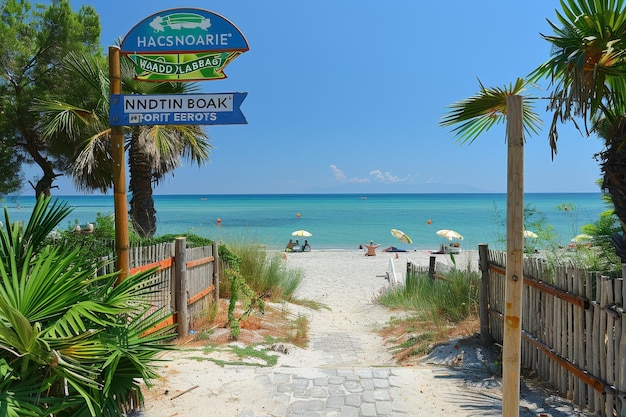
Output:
[128,134,156,237]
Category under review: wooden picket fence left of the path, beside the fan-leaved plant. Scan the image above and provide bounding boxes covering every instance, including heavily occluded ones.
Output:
[101,237,220,336]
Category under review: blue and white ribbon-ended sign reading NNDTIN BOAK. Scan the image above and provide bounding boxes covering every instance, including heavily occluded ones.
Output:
[109,93,248,126]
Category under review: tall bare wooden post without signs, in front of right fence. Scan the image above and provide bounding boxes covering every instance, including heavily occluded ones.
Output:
[502,96,524,417]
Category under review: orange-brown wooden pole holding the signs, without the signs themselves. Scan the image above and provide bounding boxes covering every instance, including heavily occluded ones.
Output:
[109,46,129,283]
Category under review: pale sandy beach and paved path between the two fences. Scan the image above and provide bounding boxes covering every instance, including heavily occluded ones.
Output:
[133,250,587,417]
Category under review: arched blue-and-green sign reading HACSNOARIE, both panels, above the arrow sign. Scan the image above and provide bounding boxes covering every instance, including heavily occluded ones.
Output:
[120,8,249,81]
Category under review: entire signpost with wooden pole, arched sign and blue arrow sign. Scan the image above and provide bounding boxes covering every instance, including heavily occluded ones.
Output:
[109,8,249,283]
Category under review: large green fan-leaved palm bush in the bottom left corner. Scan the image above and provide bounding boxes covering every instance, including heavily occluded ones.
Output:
[0,198,172,417]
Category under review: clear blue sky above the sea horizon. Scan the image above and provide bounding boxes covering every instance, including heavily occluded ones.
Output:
[26,0,602,195]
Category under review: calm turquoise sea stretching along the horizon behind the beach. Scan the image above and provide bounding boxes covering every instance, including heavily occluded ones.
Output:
[2,192,608,250]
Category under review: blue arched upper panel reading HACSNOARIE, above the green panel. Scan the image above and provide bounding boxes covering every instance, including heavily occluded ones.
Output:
[120,8,249,55]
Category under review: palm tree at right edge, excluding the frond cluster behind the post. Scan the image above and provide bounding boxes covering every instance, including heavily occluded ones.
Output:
[531,0,626,240]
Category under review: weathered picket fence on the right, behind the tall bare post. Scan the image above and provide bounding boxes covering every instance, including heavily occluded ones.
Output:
[479,245,626,416]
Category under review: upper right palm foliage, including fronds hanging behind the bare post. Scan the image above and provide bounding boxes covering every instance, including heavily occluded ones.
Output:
[441,0,626,262]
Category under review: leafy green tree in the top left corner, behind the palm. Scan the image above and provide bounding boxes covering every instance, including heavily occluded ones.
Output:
[0,0,100,195]
